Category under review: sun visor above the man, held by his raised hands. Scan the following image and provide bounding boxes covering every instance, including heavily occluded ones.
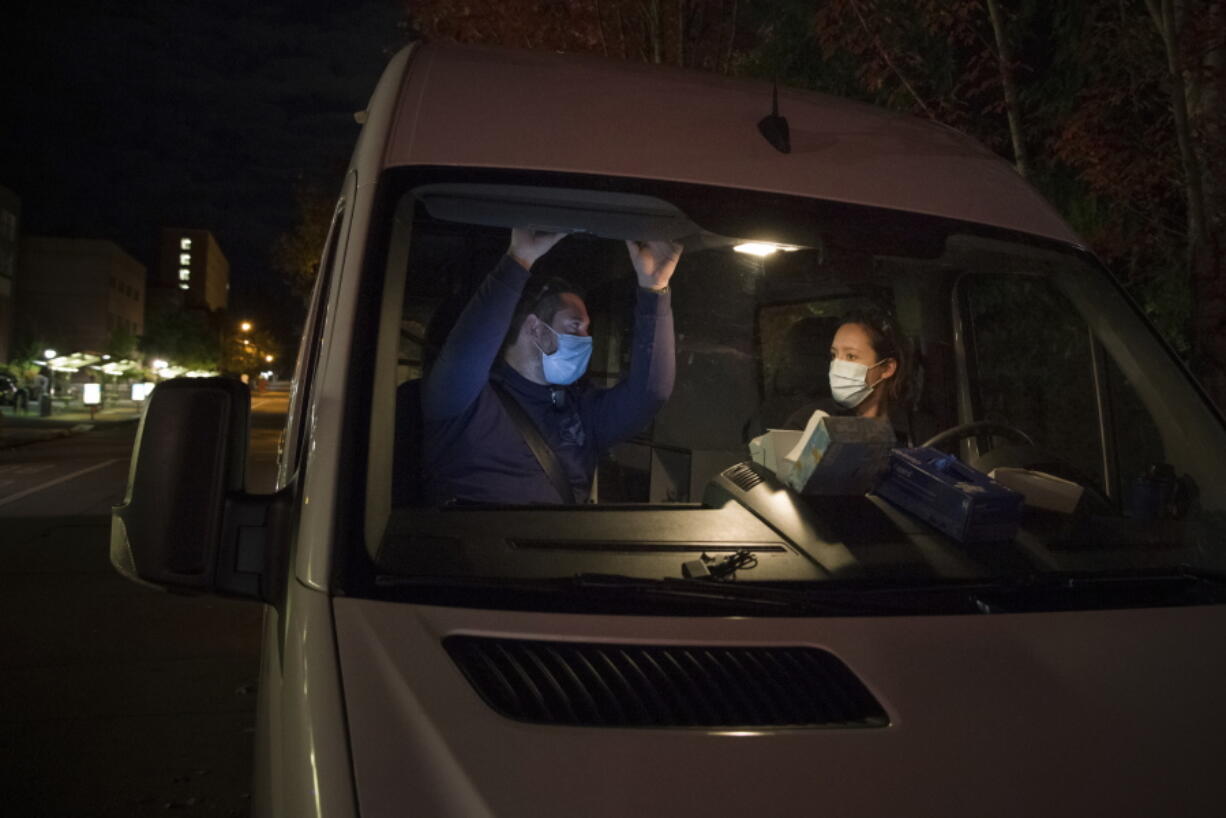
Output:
[413,184,702,244]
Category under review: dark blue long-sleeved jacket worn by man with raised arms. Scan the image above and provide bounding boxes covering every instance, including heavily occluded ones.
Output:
[422,256,677,504]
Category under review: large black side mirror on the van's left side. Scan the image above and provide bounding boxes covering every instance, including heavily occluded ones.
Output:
[110,378,286,600]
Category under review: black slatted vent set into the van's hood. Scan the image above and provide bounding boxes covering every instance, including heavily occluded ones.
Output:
[443,636,889,727]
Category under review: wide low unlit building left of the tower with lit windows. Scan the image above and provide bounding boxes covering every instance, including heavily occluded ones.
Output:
[17,235,145,353]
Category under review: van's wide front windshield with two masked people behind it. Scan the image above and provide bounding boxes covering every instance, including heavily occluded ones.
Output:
[365,169,1226,610]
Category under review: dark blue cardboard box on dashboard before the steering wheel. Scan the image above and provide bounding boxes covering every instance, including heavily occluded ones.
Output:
[877,448,1024,542]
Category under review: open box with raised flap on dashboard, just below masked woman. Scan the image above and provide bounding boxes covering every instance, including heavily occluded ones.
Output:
[786,412,895,495]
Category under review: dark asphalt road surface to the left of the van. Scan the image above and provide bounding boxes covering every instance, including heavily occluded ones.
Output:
[0,392,286,818]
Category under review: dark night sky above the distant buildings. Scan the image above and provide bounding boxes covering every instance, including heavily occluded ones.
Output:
[0,0,407,341]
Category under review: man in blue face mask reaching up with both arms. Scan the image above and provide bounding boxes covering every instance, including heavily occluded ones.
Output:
[422,228,680,505]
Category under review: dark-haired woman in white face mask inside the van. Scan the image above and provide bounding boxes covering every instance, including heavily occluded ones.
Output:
[787,314,906,439]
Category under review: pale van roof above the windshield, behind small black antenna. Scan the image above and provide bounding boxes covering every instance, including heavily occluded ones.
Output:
[371,42,1083,247]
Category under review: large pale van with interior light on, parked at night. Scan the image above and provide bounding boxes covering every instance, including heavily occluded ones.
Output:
[112,44,1226,818]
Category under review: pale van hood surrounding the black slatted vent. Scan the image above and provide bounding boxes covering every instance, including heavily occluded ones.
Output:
[333,598,1226,818]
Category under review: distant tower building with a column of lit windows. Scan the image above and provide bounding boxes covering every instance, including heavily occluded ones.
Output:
[151,227,229,313]
